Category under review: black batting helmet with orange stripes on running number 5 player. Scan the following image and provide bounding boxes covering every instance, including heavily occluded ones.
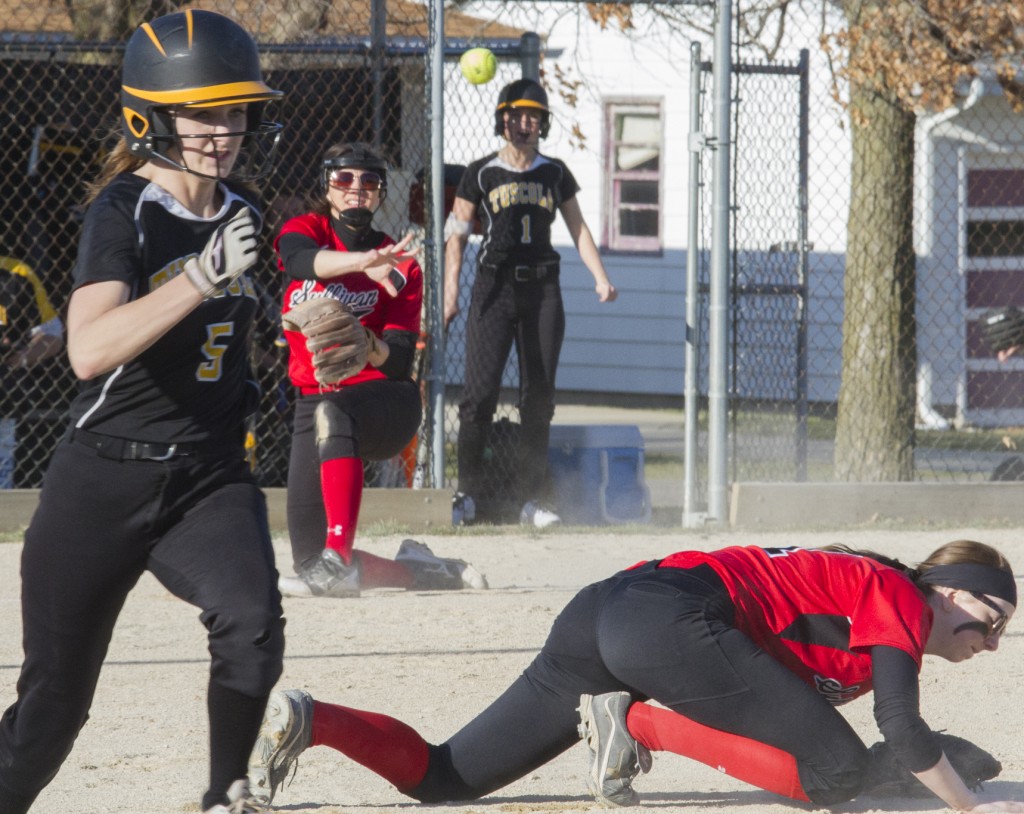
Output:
[121,9,284,179]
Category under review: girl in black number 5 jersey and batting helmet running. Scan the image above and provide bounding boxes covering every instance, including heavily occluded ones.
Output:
[0,10,284,814]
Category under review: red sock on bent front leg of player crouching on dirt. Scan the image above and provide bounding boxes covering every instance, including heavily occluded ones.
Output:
[626,703,809,802]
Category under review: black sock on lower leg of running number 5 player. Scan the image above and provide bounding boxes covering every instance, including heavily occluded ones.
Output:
[203,680,269,811]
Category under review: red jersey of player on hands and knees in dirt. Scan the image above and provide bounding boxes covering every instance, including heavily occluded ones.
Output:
[659,547,933,704]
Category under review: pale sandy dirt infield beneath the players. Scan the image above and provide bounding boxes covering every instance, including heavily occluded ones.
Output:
[0,528,1024,814]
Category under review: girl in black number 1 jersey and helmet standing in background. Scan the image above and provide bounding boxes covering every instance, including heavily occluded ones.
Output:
[444,79,617,526]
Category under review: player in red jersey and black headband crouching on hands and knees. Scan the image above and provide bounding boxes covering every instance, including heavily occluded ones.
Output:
[249,540,1024,814]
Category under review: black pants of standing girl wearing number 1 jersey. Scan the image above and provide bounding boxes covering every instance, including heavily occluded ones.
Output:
[459,267,565,499]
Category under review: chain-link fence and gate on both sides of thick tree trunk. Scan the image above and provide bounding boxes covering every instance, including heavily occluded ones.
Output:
[679,41,1024,495]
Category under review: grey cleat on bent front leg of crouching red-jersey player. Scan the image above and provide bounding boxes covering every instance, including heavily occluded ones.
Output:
[579,692,652,808]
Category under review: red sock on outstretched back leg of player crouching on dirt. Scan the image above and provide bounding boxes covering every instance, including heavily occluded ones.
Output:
[310,701,430,794]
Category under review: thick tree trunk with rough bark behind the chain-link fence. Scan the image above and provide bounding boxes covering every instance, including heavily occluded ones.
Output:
[835,81,916,481]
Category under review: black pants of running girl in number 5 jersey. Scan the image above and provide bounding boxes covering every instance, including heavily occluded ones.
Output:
[0,441,285,814]
